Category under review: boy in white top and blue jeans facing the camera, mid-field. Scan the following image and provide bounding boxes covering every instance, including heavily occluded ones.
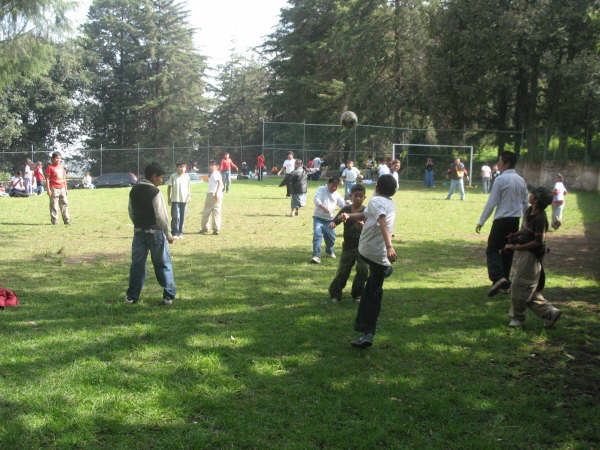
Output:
[311,177,345,264]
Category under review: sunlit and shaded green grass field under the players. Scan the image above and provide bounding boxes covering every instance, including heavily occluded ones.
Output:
[0,180,600,449]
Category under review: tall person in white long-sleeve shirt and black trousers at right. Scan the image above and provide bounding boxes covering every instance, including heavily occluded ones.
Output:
[475,151,528,297]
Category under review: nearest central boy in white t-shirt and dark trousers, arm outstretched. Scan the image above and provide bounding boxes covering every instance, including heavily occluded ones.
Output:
[342,175,396,348]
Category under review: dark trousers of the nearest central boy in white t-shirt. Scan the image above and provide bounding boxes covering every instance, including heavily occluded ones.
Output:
[354,256,386,334]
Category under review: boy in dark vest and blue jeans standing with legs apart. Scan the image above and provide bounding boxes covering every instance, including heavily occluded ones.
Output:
[125,163,175,305]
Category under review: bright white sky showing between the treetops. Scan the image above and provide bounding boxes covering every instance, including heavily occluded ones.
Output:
[71,0,287,68]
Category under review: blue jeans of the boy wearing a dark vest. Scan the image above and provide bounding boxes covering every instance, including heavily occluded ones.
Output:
[127,230,175,300]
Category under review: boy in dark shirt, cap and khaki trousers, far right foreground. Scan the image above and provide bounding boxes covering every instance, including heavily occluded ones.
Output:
[505,187,561,328]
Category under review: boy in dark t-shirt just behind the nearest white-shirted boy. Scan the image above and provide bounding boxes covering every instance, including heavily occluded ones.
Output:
[329,184,369,303]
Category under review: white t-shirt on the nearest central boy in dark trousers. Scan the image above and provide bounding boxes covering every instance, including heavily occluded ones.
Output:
[358,195,396,266]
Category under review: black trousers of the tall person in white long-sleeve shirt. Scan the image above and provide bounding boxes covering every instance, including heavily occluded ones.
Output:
[485,217,519,283]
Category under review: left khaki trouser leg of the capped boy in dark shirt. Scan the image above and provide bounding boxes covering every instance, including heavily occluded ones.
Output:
[511,250,541,322]
